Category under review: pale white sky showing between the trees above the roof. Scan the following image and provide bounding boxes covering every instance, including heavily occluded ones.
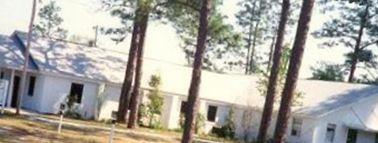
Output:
[0,0,354,78]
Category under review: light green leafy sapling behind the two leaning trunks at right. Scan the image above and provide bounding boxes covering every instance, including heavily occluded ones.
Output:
[257,44,304,106]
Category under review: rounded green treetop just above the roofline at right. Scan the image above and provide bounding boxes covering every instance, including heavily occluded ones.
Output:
[311,63,344,81]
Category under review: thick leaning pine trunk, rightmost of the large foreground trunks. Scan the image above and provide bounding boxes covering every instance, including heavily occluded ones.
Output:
[274,0,315,143]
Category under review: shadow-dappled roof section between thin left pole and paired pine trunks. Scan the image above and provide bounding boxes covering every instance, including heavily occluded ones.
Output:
[13,31,127,83]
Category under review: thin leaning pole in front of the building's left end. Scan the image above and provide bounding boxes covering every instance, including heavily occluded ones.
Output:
[16,0,37,115]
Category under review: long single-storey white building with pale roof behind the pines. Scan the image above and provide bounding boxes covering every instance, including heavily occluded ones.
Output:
[0,31,378,143]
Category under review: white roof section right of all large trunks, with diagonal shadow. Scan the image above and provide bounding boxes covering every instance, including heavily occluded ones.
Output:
[295,80,378,117]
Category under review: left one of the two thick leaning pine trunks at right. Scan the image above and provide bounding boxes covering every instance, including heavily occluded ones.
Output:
[257,0,290,143]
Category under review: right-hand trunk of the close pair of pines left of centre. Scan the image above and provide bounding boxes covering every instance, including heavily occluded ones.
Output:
[127,9,149,128]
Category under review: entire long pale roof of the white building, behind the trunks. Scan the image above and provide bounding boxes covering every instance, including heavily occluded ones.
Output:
[6,32,378,117]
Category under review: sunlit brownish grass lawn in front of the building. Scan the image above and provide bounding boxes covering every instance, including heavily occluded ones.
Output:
[0,114,179,143]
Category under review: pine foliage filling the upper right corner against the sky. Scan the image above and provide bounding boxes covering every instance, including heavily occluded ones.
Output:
[312,0,378,80]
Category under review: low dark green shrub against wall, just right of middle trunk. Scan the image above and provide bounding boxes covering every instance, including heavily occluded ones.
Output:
[212,107,235,139]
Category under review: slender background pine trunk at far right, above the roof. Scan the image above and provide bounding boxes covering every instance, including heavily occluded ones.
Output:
[348,4,369,82]
